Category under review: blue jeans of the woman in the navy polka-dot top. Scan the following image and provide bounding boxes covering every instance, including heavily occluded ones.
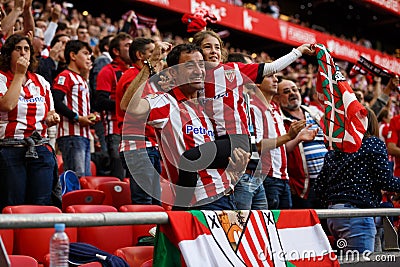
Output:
[327,203,376,253]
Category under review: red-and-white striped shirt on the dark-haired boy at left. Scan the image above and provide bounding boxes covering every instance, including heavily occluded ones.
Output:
[53,69,90,138]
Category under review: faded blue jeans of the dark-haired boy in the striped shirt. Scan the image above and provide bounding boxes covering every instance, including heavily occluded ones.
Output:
[57,135,91,177]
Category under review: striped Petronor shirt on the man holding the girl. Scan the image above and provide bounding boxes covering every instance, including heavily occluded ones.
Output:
[145,88,231,202]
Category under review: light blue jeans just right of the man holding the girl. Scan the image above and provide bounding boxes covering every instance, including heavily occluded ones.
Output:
[234,173,268,210]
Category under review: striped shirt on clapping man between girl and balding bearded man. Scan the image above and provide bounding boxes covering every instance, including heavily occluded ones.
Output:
[250,98,289,179]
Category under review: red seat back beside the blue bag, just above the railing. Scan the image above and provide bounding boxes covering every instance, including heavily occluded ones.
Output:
[62,189,105,212]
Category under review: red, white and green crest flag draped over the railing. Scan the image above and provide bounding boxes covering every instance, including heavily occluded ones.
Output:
[153,210,339,267]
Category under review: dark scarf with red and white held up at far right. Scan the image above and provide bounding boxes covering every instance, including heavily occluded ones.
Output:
[350,56,395,84]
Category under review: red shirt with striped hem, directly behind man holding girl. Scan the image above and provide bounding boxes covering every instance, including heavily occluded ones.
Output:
[115,64,157,152]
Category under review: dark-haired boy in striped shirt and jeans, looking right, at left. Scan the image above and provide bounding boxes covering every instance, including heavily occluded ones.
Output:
[52,40,97,177]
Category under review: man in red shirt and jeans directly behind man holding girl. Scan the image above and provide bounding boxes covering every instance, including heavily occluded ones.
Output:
[115,37,161,205]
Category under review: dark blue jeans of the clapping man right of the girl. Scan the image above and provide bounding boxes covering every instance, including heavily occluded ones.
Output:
[264,176,292,210]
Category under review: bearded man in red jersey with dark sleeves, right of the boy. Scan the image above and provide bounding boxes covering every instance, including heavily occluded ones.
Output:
[96,32,132,179]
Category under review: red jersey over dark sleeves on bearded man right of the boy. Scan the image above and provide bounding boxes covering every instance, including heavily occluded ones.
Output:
[96,59,128,135]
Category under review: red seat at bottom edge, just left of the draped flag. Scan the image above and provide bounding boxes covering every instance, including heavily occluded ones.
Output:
[114,246,154,266]
